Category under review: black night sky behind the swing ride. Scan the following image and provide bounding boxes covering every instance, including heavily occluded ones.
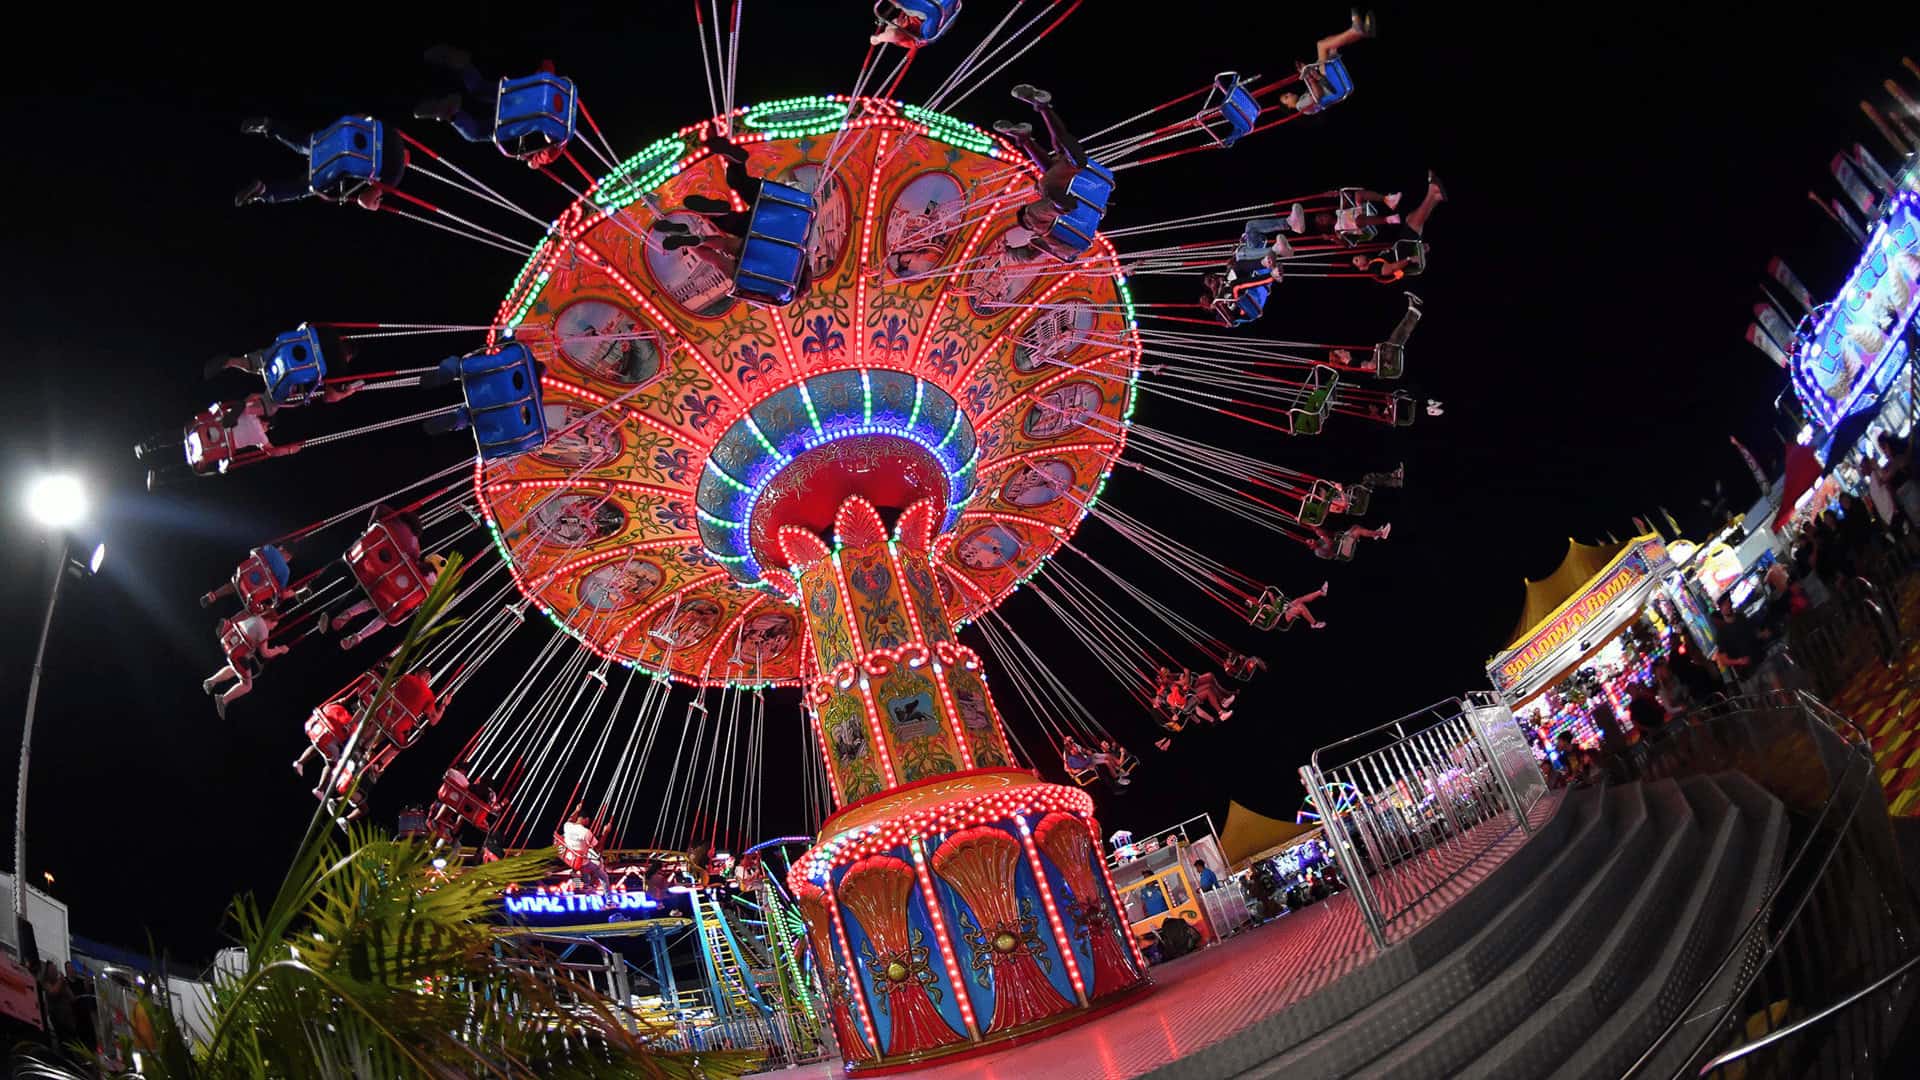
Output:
[0,0,1914,959]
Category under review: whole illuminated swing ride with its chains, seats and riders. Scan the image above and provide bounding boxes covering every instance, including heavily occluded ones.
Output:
[140,0,1444,1068]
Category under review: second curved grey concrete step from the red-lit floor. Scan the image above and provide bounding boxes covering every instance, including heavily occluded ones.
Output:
[1244,776,1645,1078]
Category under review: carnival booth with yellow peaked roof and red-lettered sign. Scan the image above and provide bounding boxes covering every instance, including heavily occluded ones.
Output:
[1486,534,1713,751]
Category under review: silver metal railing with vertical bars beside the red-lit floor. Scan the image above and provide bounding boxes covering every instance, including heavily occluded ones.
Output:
[1300,694,1546,949]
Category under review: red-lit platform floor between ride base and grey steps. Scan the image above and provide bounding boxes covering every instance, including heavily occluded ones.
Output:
[776,794,1559,1080]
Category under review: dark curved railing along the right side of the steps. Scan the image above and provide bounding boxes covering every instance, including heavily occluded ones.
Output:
[1622,692,1920,1078]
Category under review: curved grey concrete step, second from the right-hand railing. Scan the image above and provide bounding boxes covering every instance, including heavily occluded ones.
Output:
[1467,780,1704,1076]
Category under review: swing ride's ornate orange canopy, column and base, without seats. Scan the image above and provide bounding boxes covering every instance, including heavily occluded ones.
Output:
[476,98,1144,1067]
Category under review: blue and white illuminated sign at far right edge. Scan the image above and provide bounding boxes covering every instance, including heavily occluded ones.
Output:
[1793,190,1920,429]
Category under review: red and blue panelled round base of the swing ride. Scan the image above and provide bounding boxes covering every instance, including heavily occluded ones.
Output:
[793,769,1148,1074]
